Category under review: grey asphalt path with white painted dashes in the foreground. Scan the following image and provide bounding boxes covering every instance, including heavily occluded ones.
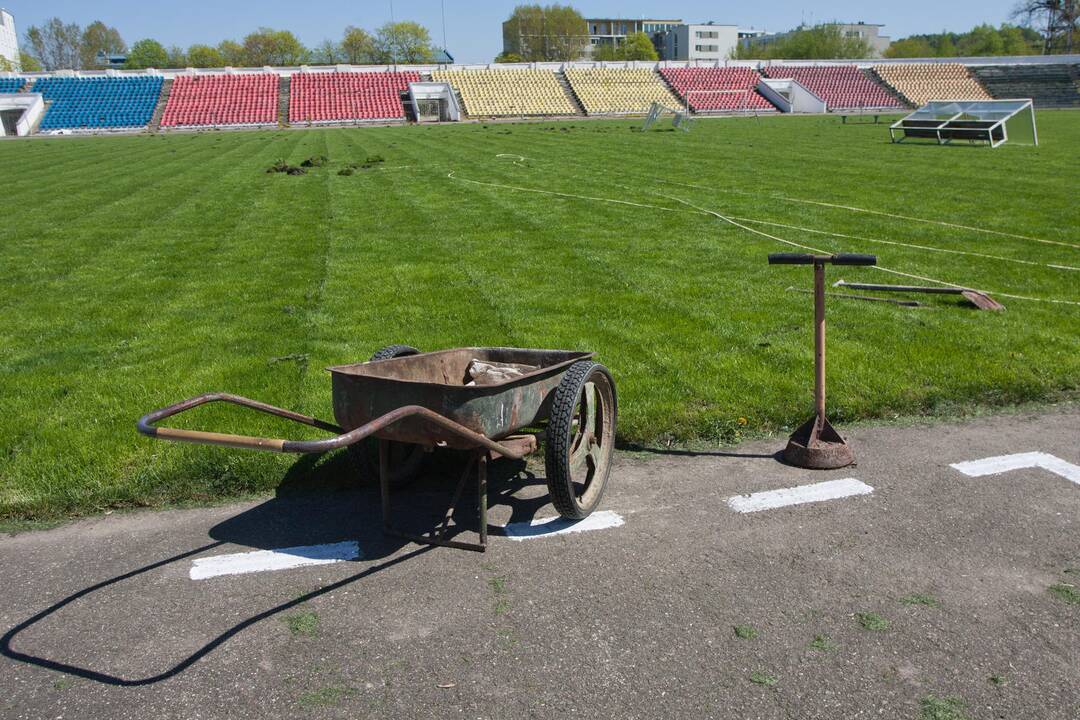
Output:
[0,406,1080,720]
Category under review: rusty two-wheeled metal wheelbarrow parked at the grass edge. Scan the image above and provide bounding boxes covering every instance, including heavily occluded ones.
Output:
[138,345,618,552]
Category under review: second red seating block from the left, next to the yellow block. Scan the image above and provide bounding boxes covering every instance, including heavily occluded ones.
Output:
[288,72,420,123]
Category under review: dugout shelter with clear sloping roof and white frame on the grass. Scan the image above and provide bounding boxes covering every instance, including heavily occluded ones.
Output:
[889,99,1039,148]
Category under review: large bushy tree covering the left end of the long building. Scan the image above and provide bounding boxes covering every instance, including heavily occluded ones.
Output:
[502,3,589,63]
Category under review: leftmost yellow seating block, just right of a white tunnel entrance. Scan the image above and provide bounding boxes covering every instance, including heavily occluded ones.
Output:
[431,68,580,118]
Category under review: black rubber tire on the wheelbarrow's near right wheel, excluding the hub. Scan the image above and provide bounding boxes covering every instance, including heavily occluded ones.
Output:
[544,361,619,520]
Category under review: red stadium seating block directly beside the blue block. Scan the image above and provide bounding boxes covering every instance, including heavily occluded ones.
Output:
[161,72,278,127]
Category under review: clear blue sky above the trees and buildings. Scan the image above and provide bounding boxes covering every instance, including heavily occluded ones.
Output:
[6,0,1015,63]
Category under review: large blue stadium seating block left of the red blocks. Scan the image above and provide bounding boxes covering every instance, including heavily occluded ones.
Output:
[33,76,162,132]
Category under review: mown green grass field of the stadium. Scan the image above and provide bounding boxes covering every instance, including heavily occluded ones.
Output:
[0,111,1080,520]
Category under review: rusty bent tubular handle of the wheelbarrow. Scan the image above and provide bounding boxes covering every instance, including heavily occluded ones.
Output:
[137,393,525,460]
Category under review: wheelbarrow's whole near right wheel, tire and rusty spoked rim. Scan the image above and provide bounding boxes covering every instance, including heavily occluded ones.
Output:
[544,361,619,520]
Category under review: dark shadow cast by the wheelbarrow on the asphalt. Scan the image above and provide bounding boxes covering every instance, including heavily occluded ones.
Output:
[0,452,548,687]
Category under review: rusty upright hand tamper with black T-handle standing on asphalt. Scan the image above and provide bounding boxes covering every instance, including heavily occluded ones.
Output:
[769,253,877,470]
